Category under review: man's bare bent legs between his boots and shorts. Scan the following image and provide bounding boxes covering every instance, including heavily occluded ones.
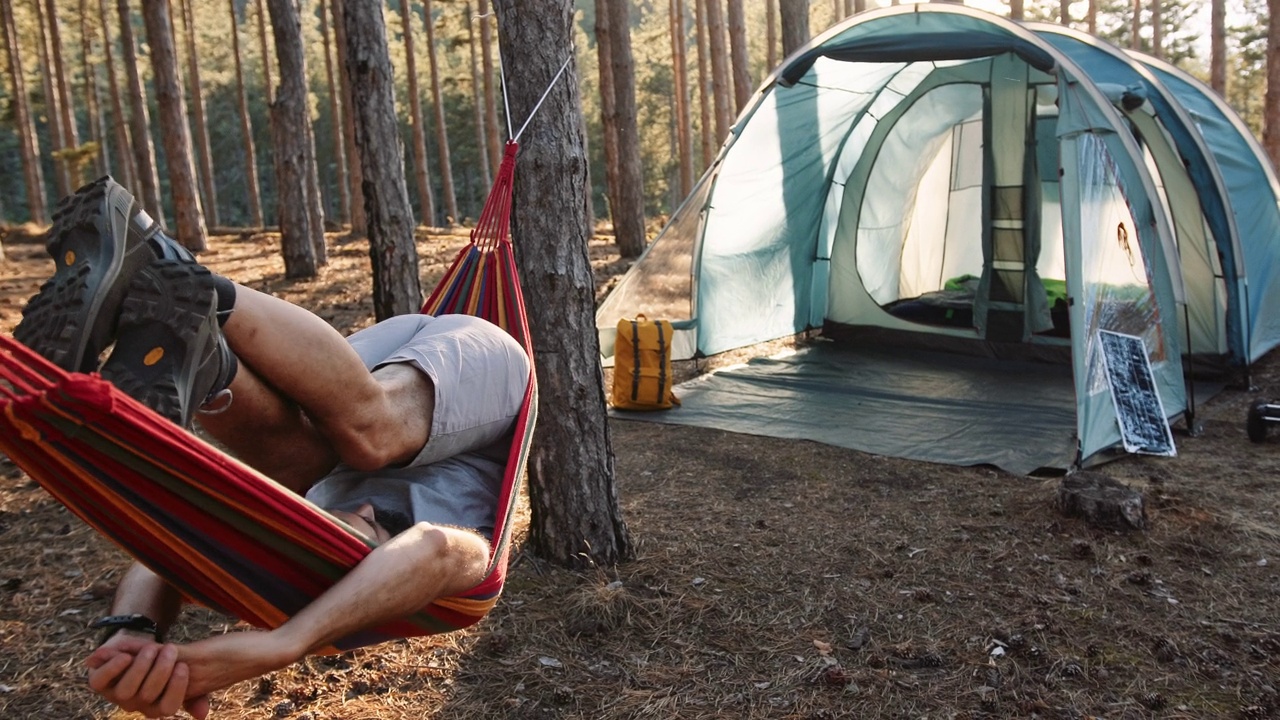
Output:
[198,286,435,492]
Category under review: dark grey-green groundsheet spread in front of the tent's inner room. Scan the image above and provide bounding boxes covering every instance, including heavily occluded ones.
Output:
[611,341,1075,474]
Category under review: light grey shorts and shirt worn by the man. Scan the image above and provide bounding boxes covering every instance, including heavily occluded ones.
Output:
[307,315,529,536]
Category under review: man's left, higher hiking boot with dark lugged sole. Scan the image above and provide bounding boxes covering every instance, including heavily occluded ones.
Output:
[13,177,163,372]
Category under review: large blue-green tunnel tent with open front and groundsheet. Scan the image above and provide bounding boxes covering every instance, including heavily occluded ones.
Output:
[596,4,1276,473]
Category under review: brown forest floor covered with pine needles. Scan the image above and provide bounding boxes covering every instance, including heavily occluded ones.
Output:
[0,225,1280,720]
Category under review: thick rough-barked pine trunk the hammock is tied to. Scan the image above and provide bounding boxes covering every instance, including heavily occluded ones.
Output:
[495,0,632,568]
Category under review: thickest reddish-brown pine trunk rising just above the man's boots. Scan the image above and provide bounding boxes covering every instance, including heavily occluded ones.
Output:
[142,0,209,252]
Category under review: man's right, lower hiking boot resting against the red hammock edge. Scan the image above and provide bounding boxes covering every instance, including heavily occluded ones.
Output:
[102,259,237,428]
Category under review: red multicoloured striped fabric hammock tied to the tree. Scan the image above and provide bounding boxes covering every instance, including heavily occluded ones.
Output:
[0,142,538,652]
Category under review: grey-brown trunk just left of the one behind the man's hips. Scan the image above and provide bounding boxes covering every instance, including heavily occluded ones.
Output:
[266,0,324,278]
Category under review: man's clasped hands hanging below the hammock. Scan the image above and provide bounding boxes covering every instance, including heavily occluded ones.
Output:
[84,632,209,720]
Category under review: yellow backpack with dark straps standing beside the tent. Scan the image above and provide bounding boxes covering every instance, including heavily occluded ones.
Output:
[611,315,680,410]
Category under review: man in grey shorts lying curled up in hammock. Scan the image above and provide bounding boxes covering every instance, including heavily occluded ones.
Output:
[14,178,529,717]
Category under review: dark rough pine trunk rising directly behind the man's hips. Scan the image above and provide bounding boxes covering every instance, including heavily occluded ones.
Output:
[342,0,422,313]
